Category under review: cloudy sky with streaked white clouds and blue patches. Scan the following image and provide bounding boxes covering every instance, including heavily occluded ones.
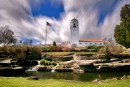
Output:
[0,0,130,44]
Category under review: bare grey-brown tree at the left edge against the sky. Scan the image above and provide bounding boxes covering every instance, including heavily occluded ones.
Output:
[0,26,16,46]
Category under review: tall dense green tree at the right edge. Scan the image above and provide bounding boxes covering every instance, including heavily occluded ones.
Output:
[114,5,130,48]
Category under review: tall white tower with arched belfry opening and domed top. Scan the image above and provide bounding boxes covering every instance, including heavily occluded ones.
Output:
[70,18,79,48]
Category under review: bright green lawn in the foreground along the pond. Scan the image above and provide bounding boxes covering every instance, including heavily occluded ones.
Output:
[0,77,130,87]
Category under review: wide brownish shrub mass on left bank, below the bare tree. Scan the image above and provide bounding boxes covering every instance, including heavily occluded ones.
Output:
[0,46,42,60]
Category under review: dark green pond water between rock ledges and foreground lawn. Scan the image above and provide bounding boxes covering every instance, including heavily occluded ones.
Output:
[26,71,130,82]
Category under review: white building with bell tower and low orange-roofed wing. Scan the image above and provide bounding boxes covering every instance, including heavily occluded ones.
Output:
[70,18,104,48]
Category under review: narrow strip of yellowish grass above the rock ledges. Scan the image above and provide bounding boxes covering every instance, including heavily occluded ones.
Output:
[43,52,97,56]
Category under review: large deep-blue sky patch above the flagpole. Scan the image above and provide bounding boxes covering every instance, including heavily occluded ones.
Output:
[31,0,64,19]
